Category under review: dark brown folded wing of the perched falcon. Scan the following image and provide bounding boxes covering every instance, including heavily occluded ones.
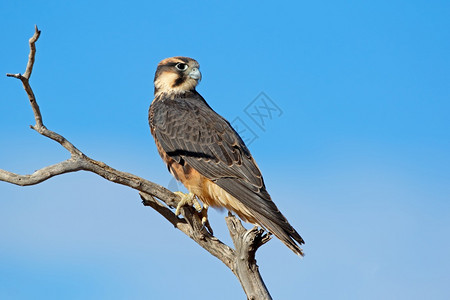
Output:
[149,93,304,254]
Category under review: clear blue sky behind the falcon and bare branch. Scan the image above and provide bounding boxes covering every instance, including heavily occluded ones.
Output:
[0,0,450,299]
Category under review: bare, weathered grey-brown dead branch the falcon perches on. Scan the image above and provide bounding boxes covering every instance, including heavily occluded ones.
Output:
[0,26,271,299]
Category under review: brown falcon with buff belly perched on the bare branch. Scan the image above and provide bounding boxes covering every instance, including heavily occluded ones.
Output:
[148,56,304,256]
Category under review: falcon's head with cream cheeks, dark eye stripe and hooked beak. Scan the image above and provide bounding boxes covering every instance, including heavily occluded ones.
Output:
[154,56,202,95]
